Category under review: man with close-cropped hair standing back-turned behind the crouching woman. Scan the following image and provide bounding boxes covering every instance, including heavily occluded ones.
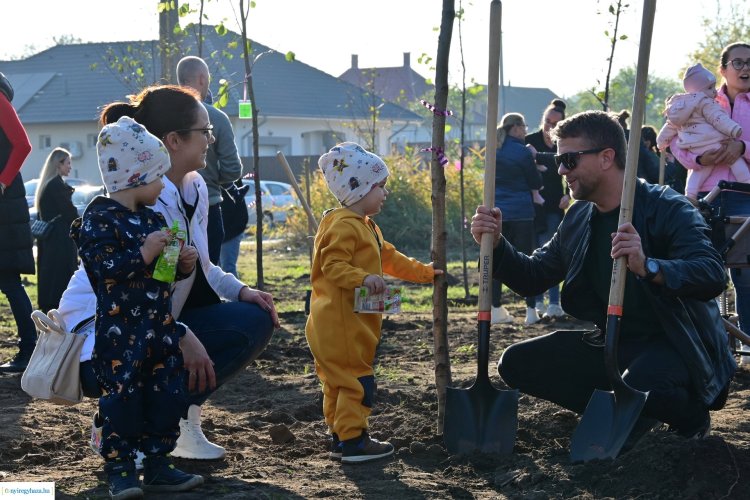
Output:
[177,56,242,265]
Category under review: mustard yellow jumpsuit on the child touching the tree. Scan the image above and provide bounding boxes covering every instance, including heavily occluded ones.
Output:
[305,208,435,441]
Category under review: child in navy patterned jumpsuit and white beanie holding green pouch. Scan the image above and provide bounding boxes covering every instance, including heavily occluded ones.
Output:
[71,117,203,499]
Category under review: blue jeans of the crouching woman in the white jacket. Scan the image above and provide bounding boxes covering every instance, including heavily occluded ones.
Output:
[80,302,273,406]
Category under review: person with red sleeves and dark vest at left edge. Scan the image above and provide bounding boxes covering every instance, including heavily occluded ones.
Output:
[0,73,36,372]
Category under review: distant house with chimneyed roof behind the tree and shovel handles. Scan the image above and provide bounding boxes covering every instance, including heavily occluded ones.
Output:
[339,52,557,145]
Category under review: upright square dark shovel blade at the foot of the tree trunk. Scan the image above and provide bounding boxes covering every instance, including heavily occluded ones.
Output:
[443,379,518,455]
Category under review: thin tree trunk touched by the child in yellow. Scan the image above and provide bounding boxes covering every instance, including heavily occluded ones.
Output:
[430,0,456,434]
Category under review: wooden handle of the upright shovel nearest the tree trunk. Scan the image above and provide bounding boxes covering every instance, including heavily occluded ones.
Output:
[479,0,501,320]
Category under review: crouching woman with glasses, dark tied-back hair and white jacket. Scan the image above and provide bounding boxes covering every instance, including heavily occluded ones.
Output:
[59,85,279,460]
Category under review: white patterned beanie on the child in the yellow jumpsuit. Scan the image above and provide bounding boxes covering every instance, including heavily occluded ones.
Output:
[318,142,389,207]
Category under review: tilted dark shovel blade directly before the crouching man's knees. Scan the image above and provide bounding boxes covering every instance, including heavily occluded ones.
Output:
[570,388,648,463]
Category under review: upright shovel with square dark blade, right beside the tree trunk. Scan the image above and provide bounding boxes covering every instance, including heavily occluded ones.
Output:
[443,0,518,454]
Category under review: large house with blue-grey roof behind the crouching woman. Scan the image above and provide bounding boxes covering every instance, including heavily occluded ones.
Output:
[0,26,423,183]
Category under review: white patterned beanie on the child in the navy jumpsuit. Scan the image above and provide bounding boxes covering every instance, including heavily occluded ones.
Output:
[96,116,171,193]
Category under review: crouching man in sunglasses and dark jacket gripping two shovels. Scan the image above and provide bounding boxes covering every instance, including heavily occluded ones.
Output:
[471,111,736,446]
